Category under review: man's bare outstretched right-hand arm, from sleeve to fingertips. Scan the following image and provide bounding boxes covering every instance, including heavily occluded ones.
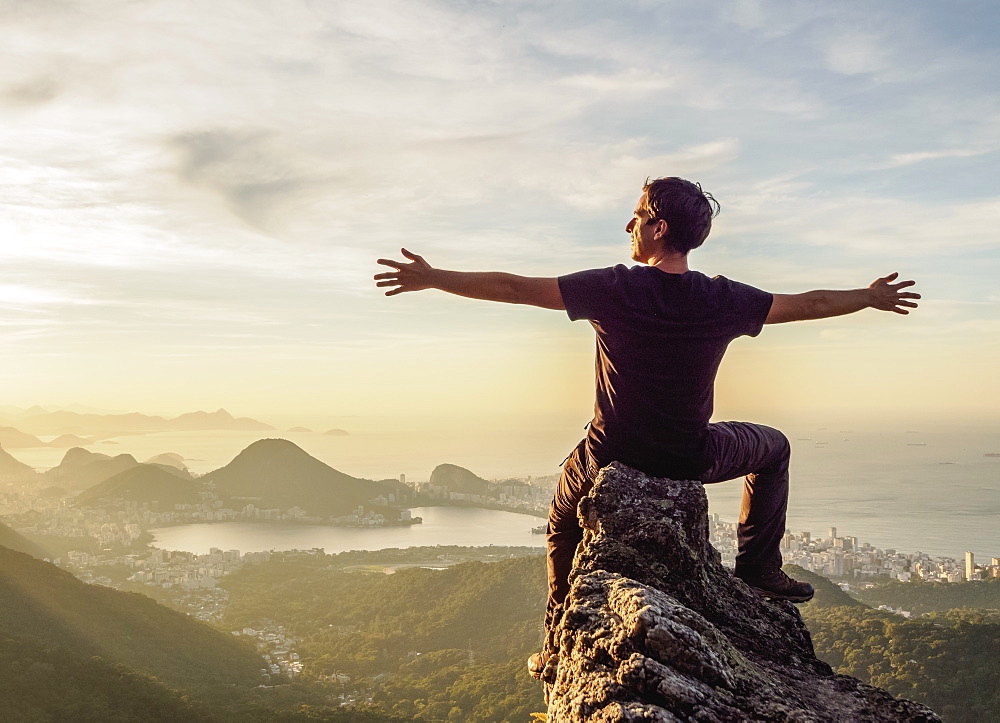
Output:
[764,273,920,324]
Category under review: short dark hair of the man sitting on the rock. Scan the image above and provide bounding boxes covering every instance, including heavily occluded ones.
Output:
[642,177,719,254]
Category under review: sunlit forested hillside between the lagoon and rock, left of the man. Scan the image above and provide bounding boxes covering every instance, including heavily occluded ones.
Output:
[221,553,546,722]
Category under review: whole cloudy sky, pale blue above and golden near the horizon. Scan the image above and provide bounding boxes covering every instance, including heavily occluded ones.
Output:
[0,0,1000,438]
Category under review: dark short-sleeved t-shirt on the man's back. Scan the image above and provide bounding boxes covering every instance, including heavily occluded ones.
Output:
[559,265,772,479]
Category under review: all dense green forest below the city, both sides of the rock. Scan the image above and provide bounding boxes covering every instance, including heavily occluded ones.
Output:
[0,536,1000,723]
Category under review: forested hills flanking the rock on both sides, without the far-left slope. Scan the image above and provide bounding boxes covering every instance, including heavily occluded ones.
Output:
[205,549,1000,723]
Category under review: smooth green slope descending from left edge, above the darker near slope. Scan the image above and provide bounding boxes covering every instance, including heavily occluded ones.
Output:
[0,548,261,691]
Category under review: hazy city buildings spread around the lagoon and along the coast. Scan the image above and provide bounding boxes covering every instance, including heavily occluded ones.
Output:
[0,466,1000,590]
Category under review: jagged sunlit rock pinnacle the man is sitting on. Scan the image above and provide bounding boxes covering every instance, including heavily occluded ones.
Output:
[543,463,940,723]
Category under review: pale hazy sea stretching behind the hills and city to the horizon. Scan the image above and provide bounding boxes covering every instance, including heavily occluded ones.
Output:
[0,398,1000,558]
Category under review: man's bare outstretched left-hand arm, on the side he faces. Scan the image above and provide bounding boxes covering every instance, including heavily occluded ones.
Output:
[375,249,566,309]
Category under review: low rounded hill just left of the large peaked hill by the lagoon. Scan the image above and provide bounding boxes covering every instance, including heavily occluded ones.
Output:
[74,464,201,512]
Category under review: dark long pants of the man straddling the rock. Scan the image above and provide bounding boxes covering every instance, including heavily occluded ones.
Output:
[545,422,791,629]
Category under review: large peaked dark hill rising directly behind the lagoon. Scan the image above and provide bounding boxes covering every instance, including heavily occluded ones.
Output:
[203,439,398,517]
